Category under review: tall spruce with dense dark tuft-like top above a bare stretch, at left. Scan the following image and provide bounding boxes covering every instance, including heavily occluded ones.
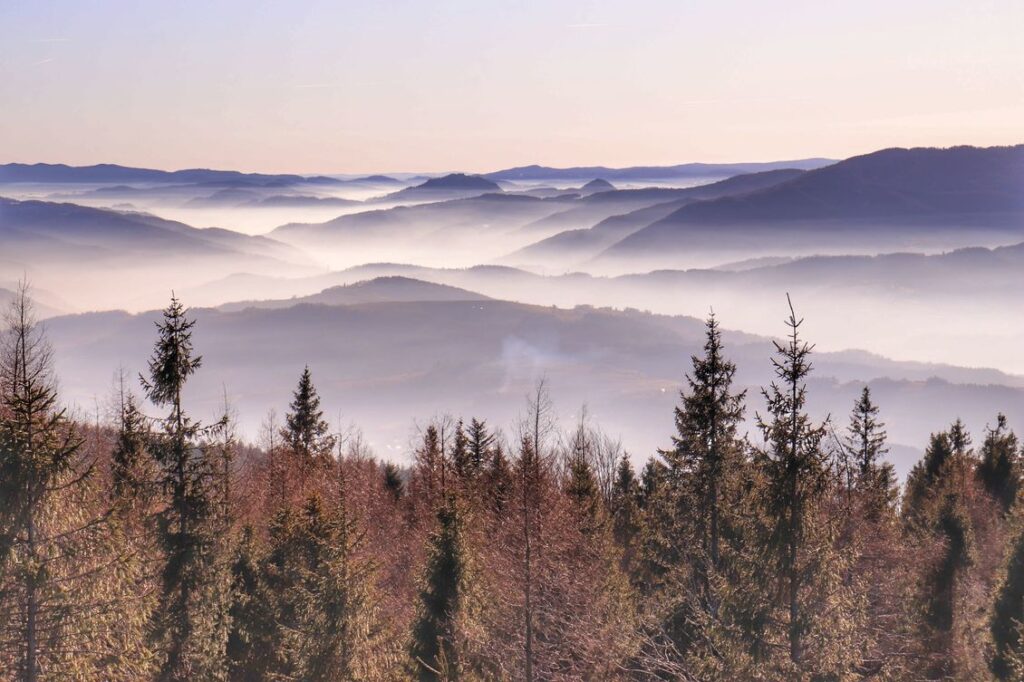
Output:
[141,297,227,681]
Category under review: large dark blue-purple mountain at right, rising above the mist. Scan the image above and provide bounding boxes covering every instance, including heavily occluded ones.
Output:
[605,145,1024,263]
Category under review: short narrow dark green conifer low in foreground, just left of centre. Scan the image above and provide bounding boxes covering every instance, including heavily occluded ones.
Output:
[412,496,467,681]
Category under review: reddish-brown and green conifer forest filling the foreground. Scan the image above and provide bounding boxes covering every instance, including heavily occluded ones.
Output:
[0,289,1024,682]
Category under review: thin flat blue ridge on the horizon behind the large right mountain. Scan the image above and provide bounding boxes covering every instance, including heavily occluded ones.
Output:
[483,159,836,182]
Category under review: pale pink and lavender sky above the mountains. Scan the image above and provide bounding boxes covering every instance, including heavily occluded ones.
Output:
[0,0,1024,173]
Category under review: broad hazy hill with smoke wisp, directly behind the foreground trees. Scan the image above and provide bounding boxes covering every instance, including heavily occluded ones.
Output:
[39,300,1024,472]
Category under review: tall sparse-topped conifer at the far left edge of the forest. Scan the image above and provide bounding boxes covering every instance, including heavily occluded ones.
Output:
[0,285,87,682]
